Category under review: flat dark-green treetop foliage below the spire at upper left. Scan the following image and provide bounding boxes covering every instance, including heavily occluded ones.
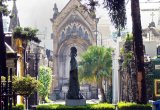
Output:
[13,27,41,43]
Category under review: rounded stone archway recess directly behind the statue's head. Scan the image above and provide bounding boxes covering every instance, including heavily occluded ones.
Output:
[57,37,91,87]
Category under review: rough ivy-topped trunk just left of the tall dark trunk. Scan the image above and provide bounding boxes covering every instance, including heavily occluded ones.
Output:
[120,34,138,102]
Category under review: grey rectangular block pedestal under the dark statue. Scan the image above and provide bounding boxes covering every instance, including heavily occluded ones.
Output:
[65,98,86,106]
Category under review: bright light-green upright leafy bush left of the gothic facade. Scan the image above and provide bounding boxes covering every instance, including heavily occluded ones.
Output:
[38,66,52,100]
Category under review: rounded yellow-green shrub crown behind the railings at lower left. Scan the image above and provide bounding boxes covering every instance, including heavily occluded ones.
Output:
[12,75,40,96]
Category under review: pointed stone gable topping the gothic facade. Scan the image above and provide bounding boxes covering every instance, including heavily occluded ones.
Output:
[52,0,96,33]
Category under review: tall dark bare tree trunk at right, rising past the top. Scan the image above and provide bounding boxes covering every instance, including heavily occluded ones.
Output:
[131,0,147,104]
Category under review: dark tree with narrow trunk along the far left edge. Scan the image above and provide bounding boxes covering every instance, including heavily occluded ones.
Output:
[0,0,12,109]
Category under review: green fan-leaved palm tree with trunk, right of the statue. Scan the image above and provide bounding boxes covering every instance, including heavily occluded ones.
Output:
[79,46,112,102]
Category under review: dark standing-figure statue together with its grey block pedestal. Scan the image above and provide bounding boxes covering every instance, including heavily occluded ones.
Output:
[66,47,86,106]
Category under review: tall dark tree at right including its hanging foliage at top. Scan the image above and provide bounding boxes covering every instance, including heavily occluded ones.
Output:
[88,0,147,104]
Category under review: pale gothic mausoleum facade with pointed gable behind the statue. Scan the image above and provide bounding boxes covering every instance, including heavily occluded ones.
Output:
[51,0,97,98]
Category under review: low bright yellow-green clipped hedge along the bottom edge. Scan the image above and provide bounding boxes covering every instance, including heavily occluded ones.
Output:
[36,102,152,110]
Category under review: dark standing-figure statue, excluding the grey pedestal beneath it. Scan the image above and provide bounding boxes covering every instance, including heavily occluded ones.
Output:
[67,47,83,99]
